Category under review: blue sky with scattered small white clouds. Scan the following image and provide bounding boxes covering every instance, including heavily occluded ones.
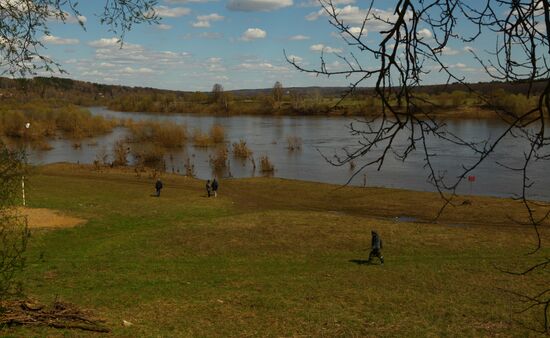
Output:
[40,0,500,91]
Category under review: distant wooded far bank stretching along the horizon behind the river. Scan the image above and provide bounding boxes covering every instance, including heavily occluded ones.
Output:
[0,77,544,118]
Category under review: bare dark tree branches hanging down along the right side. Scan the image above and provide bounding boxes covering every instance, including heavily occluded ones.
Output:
[285,0,550,332]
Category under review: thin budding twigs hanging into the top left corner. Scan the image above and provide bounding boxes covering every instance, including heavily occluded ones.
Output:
[0,0,158,76]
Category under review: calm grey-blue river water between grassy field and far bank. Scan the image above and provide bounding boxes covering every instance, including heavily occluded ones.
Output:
[29,107,550,200]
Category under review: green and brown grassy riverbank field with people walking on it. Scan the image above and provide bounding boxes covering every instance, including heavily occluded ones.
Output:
[0,165,550,337]
